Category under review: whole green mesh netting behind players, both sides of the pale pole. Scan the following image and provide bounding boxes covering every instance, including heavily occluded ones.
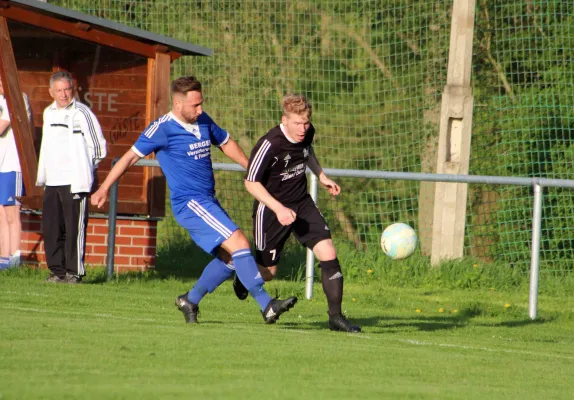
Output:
[51,0,574,269]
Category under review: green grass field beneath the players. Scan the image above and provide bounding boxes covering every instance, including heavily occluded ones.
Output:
[0,269,574,399]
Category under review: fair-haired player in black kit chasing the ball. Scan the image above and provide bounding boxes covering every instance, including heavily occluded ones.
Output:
[234,95,361,332]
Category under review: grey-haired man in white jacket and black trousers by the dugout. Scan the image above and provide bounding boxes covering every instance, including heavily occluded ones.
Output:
[36,71,106,283]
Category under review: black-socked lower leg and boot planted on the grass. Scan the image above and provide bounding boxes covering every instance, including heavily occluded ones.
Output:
[319,258,361,333]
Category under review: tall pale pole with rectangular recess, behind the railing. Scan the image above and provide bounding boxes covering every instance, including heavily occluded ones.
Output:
[431,0,476,265]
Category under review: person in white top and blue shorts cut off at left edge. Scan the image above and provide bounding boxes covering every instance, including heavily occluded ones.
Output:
[0,80,32,269]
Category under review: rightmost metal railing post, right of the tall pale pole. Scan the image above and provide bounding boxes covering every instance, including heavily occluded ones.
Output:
[528,183,542,320]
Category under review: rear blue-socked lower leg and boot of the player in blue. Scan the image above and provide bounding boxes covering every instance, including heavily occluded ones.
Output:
[175,258,233,324]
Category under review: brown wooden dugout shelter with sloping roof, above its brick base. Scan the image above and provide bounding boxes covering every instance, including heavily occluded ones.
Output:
[0,0,212,217]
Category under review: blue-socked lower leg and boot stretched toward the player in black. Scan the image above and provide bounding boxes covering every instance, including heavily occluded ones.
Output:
[231,249,297,324]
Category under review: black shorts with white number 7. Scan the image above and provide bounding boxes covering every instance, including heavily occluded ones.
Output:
[253,195,331,267]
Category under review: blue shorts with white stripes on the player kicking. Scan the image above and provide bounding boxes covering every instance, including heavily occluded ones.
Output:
[175,198,239,256]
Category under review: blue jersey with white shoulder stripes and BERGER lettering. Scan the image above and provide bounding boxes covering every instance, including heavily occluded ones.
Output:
[132,112,229,208]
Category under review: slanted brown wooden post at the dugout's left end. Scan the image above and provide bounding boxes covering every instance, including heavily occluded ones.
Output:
[0,17,42,197]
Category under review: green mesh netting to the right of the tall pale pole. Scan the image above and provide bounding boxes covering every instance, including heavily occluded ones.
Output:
[467,0,574,270]
